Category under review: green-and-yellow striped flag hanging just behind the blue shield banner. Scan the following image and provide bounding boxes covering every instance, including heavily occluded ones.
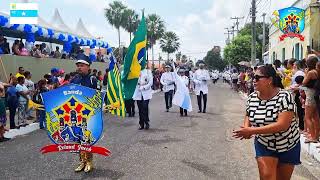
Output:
[107,55,126,117]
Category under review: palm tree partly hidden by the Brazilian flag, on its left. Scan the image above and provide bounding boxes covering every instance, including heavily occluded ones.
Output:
[123,9,140,42]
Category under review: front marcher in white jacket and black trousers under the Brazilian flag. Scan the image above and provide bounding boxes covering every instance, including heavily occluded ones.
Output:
[132,69,153,130]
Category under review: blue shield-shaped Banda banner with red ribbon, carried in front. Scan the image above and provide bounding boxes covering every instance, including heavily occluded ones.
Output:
[41,84,111,156]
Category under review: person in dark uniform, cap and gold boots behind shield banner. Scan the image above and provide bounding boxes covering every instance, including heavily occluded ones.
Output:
[70,54,97,173]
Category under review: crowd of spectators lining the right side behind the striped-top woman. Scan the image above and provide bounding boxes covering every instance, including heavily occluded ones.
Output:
[222,50,320,143]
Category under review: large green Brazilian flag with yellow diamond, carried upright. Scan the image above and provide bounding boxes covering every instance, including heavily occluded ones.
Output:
[122,13,147,100]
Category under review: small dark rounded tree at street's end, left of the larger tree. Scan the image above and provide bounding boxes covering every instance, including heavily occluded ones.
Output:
[204,49,227,71]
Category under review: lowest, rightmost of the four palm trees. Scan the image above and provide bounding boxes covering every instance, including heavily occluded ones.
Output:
[160,31,180,60]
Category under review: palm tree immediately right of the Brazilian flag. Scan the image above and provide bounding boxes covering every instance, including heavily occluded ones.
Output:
[146,14,165,67]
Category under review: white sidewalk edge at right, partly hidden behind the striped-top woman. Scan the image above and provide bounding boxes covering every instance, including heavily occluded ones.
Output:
[239,92,320,162]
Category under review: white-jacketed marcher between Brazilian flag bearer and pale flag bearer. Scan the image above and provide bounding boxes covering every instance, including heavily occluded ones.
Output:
[160,65,175,112]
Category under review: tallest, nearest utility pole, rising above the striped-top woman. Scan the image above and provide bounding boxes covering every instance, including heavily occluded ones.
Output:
[251,0,257,65]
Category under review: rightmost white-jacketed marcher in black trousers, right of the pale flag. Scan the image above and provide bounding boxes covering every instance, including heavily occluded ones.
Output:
[193,62,210,113]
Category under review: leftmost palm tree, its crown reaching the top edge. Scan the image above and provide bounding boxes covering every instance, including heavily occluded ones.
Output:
[105,1,127,48]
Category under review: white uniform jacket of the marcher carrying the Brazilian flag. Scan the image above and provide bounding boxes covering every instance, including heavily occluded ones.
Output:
[132,69,153,100]
